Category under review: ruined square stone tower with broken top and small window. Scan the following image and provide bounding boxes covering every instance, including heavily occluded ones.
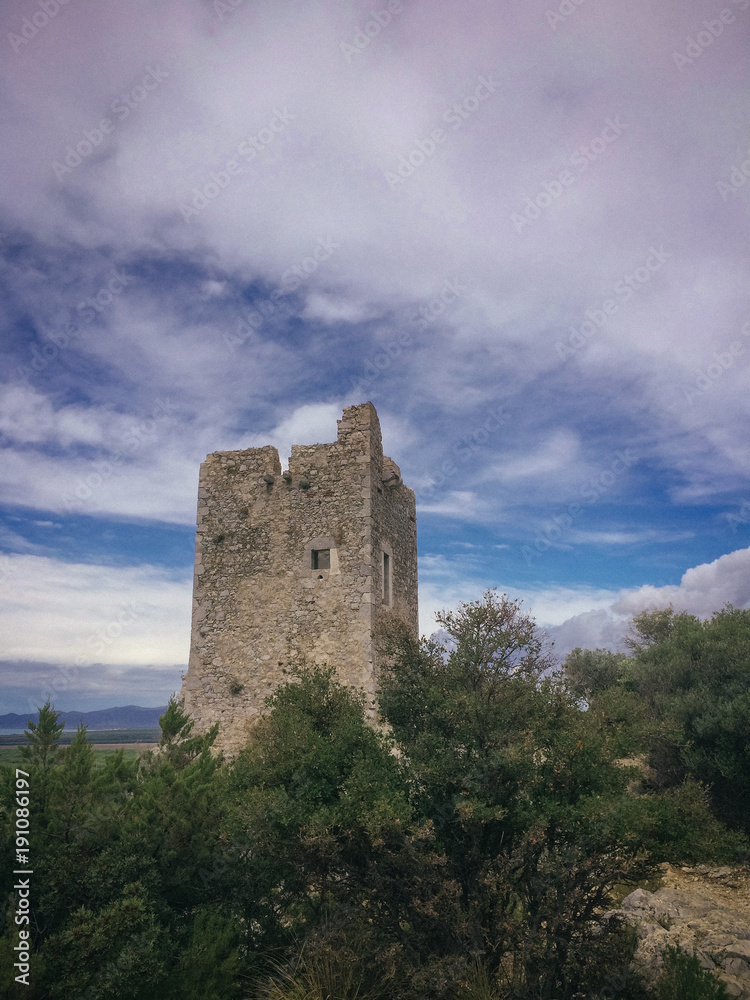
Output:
[182,403,418,753]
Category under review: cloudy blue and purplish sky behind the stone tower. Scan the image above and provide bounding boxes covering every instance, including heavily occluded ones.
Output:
[0,0,750,714]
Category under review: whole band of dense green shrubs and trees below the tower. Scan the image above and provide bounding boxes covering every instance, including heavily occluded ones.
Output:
[0,592,750,1000]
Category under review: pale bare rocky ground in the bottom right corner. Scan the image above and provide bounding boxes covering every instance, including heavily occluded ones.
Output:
[603,865,750,1000]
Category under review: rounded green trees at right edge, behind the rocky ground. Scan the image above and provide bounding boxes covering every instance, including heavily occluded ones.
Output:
[565,606,750,833]
